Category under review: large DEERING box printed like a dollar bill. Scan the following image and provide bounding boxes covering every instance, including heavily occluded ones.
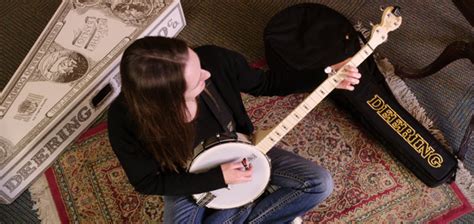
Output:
[0,0,186,204]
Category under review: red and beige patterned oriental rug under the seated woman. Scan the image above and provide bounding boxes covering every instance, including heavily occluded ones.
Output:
[32,90,472,223]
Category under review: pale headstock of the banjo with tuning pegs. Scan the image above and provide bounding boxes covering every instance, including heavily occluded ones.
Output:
[368,6,402,49]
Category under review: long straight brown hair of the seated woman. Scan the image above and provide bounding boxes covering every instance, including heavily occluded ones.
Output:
[120,36,194,171]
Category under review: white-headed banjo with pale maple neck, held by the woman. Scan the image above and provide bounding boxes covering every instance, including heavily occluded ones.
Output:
[188,6,402,209]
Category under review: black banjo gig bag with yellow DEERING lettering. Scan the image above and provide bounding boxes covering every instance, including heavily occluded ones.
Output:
[264,3,457,187]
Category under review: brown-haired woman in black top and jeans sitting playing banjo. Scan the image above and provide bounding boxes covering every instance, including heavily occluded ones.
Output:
[108,36,361,223]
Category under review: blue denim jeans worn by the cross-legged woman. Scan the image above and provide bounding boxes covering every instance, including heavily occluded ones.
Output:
[164,148,334,223]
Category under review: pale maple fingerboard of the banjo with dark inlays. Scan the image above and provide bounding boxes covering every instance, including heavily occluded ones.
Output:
[256,43,374,154]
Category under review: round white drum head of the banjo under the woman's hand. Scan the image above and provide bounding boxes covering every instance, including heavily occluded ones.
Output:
[189,142,271,209]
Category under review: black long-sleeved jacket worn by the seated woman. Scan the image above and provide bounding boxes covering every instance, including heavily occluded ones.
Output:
[108,46,326,195]
